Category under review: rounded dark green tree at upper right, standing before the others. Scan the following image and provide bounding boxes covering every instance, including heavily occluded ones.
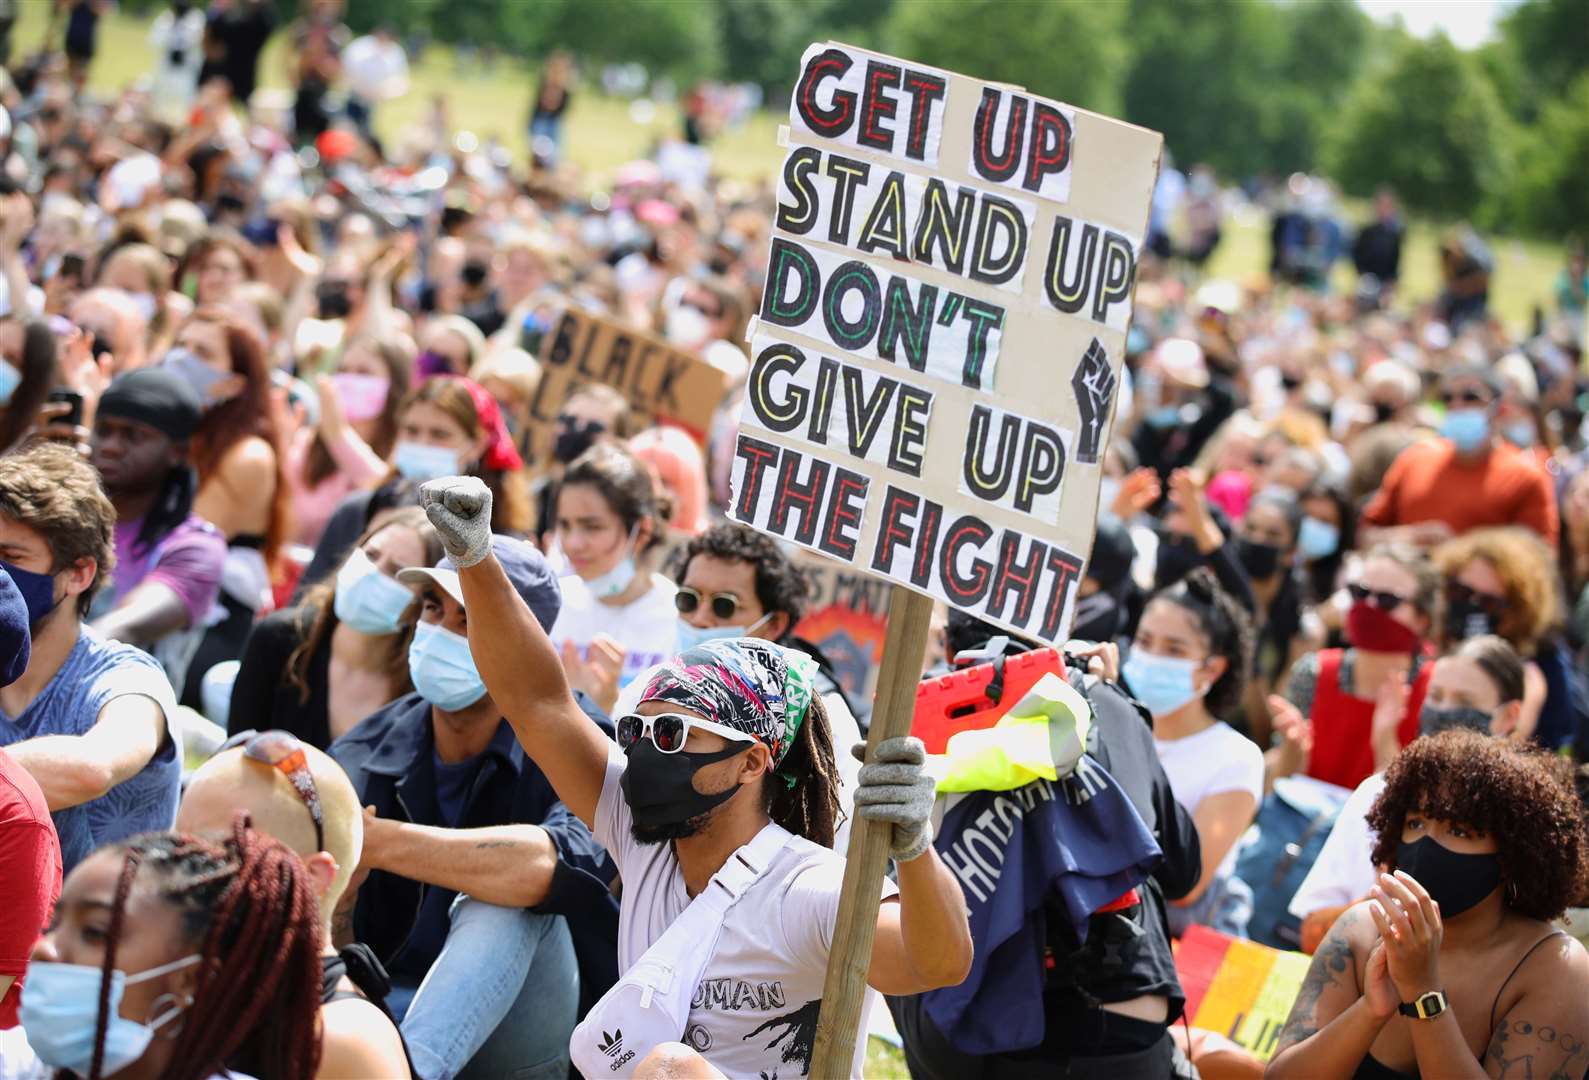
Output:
[1325,35,1514,218]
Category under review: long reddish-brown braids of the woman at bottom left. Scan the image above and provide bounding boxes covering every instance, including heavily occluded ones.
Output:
[89,813,321,1080]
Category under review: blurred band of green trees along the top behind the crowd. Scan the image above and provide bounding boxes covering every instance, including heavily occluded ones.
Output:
[108,0,1589,233]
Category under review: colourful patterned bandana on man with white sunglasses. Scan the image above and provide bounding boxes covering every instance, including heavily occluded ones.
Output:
[640,637,817,780]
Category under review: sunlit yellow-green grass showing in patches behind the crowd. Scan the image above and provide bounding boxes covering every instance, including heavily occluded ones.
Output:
[28,0,1562,330]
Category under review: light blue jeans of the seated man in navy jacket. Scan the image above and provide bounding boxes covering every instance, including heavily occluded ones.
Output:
[386,894,580,1080]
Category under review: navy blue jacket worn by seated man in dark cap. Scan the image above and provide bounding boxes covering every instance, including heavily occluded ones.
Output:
[327,694,618,1015]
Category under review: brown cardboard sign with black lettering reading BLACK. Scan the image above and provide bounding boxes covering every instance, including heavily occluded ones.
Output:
[529,308,728,459]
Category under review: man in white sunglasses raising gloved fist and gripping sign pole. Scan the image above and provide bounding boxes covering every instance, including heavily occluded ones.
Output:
[421,478,971,1077]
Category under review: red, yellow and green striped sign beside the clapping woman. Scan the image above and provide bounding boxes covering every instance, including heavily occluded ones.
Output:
[1176,926,1309,1061]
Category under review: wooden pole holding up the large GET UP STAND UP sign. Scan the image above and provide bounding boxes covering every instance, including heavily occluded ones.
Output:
[809,584,933,1080]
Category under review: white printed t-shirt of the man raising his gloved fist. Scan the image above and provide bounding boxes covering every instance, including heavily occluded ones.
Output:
[594,746,898,1080]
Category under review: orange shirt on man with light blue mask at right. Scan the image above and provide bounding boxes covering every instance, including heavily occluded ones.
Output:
[1363,438,1560,546]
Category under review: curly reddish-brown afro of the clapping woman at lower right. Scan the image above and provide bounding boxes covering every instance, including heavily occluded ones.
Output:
[1368,731,1589,921]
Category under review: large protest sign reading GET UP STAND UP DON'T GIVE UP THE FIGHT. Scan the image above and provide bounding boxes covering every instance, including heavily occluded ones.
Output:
[729,41,1163,642]
